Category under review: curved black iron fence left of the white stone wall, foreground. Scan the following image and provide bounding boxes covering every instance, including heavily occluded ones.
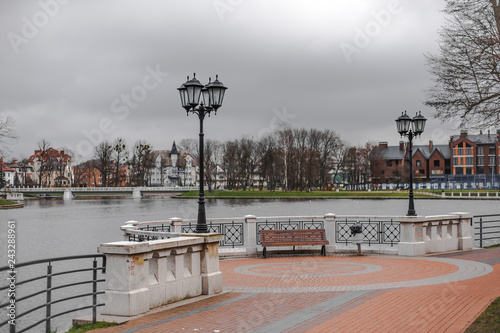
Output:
[0,254,106,333]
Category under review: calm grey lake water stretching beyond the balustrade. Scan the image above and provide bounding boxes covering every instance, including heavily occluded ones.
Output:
[0,197,500,260]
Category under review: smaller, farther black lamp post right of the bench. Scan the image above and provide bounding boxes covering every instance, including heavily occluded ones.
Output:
[396,111,427,216]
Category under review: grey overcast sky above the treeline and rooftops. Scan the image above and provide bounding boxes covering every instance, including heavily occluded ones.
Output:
[0,0,457,161]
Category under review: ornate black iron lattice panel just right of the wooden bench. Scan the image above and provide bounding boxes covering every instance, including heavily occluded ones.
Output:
[335,218,400,247]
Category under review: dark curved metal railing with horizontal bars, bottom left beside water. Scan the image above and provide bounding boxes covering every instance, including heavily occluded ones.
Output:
[0,254,106,333]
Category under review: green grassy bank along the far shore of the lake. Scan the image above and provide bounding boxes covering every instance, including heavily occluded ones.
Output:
[178,190,433,198]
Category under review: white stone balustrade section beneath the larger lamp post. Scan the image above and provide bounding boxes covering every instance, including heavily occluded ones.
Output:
[98,234,222,317]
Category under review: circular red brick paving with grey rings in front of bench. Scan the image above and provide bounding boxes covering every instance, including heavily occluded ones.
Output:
[220,256,493,293]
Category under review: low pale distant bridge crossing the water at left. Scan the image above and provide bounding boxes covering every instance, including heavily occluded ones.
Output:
[10,186,198,198]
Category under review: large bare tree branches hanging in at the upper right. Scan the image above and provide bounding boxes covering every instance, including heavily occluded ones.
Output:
[426,0,500,128]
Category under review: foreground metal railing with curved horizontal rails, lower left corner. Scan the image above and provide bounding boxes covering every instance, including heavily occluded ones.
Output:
[0,254,106,333]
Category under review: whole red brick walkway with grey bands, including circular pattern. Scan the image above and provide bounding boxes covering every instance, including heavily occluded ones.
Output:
[95,248,500,333]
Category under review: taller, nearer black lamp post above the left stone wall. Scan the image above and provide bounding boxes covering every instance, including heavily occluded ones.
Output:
[177,74,227,233]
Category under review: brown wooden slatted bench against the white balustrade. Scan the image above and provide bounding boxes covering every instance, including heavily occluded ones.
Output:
[260,229,330,258]
